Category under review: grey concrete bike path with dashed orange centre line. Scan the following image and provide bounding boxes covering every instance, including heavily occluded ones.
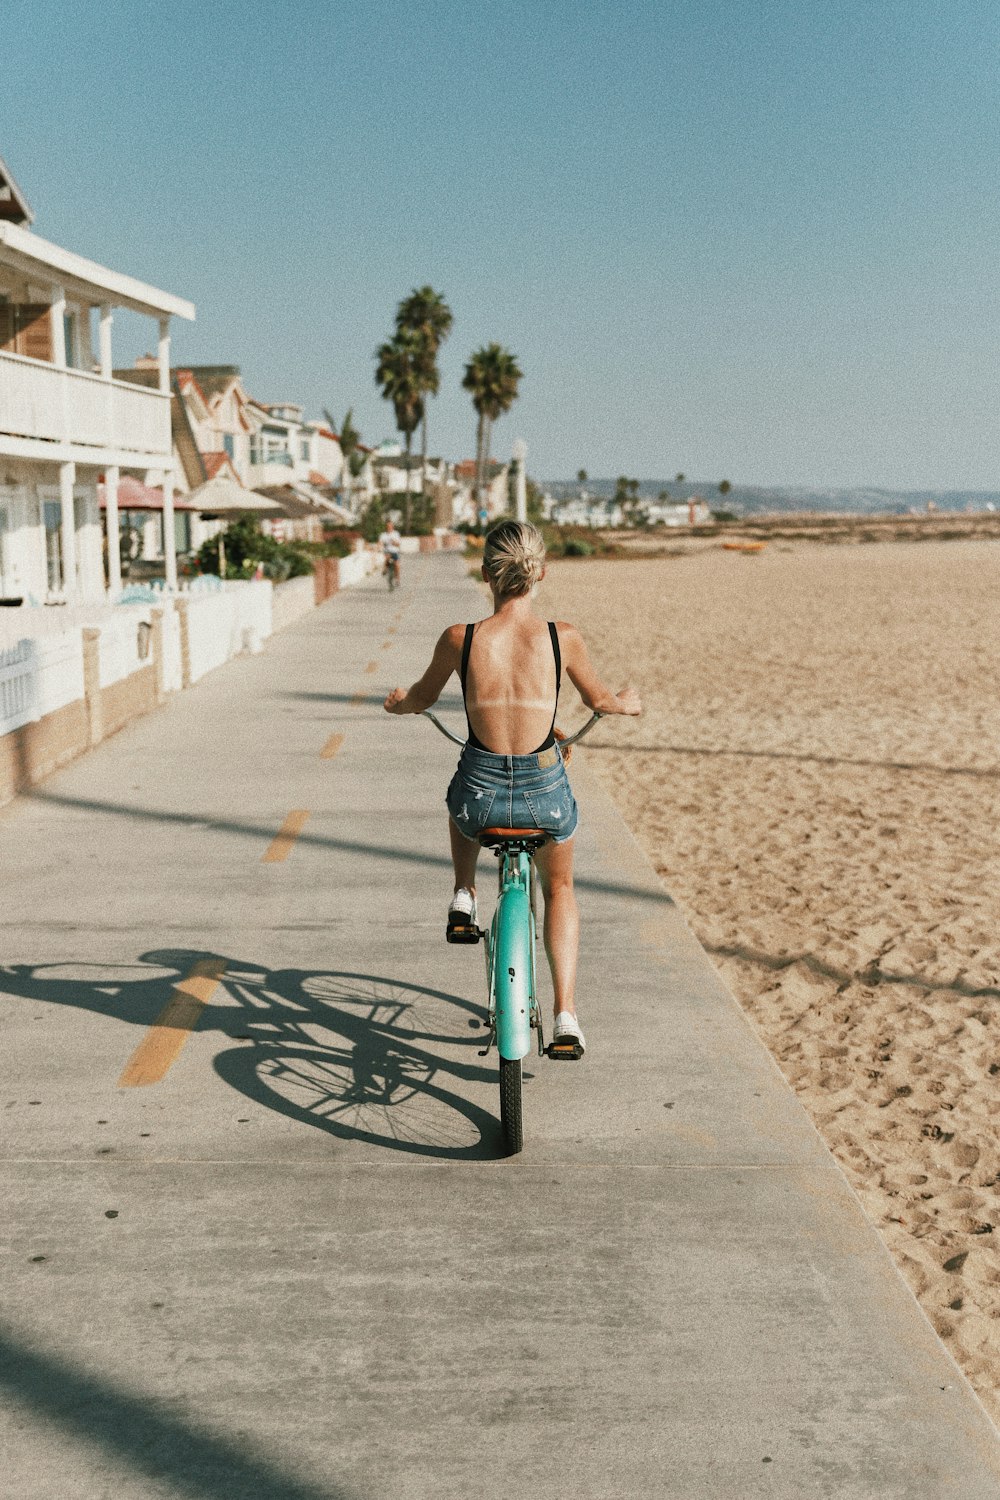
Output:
[0,557,1000,1500]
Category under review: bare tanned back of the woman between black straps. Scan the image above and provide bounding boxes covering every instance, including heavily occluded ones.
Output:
[465,614,556,755]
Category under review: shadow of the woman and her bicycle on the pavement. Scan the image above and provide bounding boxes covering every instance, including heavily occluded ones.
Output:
[0,948,502,1161]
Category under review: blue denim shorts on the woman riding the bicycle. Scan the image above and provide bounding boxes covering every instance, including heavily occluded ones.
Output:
[445,746,580,843]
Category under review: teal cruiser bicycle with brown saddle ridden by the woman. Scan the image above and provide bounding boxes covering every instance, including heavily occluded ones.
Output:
[424,708,601,1157]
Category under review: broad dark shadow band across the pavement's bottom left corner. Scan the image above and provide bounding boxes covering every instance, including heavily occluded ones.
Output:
[0,1329,360,1500]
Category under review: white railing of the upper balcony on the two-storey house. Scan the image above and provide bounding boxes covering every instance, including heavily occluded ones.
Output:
[0,354,171,462]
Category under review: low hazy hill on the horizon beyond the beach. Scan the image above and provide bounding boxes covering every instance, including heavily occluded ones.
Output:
[544,479,1000,516]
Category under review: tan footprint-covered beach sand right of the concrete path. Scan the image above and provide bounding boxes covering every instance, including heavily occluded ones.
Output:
[540,542,1000,1419]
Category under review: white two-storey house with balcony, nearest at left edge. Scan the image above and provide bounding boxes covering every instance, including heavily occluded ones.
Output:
[0,159,195,603]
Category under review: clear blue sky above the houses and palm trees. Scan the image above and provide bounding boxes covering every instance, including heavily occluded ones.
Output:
[0,0,1000,489]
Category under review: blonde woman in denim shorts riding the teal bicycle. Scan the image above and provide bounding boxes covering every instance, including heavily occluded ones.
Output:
[385,521,642,1050]
